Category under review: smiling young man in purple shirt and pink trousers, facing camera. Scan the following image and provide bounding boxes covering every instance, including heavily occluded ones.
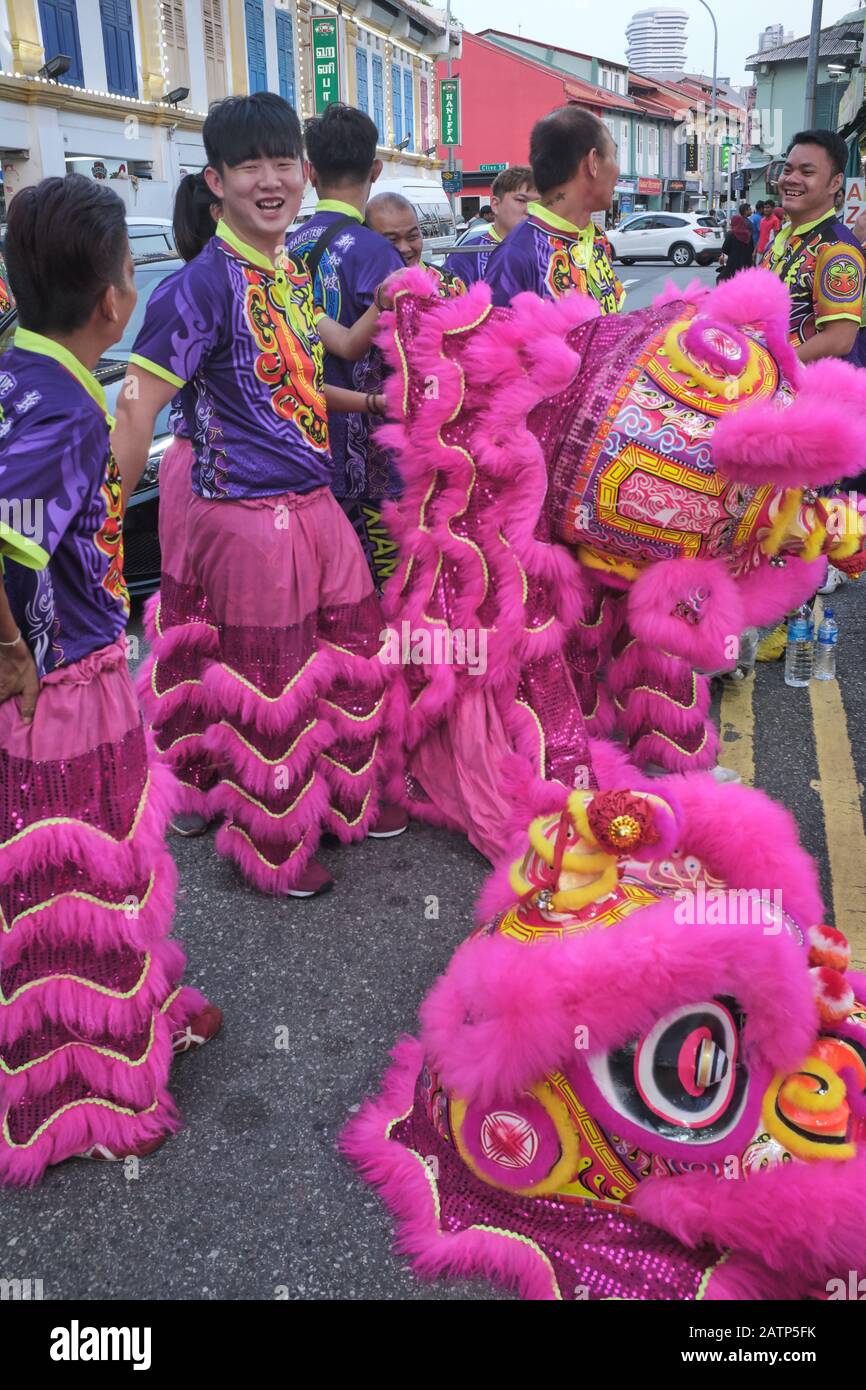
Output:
[115,92,406,897]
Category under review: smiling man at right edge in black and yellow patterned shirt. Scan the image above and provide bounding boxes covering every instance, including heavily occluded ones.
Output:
[760,131,866,364]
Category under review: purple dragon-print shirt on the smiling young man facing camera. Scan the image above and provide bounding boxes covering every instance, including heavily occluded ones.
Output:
[129,224,331,500]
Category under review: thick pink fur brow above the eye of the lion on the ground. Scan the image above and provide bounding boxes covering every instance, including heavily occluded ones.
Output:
[420,902,817,1104]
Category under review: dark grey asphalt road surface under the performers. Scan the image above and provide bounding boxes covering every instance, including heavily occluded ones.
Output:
[0,252,866,1300]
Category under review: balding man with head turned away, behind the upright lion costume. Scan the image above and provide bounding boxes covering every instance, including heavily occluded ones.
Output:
[485,106,626,314]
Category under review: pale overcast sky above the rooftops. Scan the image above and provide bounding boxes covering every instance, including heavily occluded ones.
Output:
[453,0,858,85]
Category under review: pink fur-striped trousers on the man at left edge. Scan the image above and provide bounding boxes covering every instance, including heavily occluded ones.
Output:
[0,649,183,1183]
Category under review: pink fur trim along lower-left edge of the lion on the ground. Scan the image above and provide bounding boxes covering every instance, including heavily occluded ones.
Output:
[339,1039,561,1300]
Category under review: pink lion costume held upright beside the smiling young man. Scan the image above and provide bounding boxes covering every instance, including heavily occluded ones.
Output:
[382,271,866,801]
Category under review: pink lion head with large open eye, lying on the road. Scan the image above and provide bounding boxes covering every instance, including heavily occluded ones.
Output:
[343,776,866,1300]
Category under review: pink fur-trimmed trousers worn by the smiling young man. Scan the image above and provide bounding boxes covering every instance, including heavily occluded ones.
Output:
[186,488,385,892]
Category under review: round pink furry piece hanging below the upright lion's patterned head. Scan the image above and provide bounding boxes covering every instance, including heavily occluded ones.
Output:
[628,560,745,670]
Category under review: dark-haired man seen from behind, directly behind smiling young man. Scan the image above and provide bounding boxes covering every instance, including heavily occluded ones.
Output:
[286,101,403,589]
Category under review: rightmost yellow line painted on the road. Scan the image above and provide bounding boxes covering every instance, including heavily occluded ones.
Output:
[809,596,866,969]
